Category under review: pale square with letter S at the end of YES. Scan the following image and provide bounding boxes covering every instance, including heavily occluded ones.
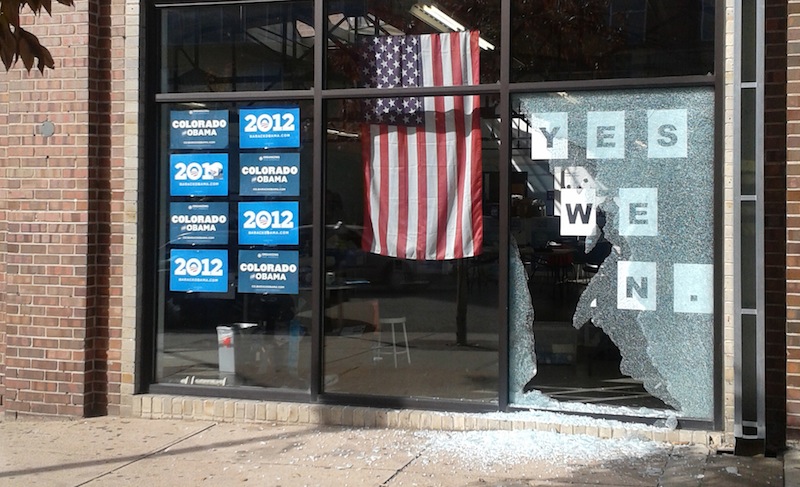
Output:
[647,109,689,159]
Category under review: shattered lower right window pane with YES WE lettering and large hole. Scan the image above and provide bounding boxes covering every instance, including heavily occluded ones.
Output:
[509,87,714,419]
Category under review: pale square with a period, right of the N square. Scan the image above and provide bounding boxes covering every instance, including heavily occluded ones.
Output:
[672,264,714,314]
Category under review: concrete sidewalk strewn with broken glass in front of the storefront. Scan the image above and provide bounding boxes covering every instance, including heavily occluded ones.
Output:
[0,417,800,487]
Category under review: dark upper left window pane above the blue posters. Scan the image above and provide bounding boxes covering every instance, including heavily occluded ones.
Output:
[161,1,314,93]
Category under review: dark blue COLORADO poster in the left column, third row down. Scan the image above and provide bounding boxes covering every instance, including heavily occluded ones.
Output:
[169,203,230,245]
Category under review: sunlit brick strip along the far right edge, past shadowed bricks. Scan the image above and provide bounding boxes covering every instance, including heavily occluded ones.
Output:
[788,0,800,440]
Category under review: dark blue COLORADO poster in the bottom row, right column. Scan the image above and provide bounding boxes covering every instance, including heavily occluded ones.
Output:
[238,250,299,294]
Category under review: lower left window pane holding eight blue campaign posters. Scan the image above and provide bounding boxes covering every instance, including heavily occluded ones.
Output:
[156,102,313,390]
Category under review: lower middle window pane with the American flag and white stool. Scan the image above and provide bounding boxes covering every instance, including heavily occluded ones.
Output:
[324,96,499,403]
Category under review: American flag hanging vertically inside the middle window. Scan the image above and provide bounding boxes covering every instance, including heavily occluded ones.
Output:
[362,32,483,260]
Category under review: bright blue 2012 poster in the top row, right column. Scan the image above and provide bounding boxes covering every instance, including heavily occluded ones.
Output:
[239,107,300,149]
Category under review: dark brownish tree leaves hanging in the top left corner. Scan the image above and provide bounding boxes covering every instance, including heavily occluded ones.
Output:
[0,0,73,72]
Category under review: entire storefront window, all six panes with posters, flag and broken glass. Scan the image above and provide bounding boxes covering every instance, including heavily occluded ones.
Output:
[153,0,719,421]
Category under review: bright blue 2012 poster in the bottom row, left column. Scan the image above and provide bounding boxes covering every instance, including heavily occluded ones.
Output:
[169,249,228,293]
